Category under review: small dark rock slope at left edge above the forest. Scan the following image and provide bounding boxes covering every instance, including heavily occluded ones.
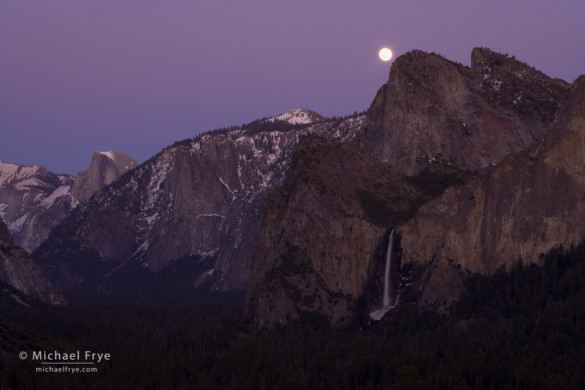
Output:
[0,219,65,305]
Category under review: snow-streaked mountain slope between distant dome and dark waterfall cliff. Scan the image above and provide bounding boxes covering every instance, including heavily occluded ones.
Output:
[34,116,364,295]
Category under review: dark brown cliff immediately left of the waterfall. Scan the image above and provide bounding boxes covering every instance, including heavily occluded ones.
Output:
[246,136,434,327]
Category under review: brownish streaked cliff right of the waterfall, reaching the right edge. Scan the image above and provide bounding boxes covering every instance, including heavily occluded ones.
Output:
[400,76,585,296]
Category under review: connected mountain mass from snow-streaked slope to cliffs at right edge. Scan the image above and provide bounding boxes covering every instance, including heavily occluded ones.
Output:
[34,48,585,327]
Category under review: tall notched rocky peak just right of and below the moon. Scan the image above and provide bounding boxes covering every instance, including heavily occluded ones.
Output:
[361,48,569,175]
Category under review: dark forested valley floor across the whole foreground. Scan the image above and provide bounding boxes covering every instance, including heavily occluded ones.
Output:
[0,245,585,389]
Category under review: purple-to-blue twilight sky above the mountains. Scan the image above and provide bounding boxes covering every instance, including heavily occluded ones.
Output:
[0,0,585,174]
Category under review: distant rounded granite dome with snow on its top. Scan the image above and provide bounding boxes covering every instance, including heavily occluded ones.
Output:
[71,152,138,202]
